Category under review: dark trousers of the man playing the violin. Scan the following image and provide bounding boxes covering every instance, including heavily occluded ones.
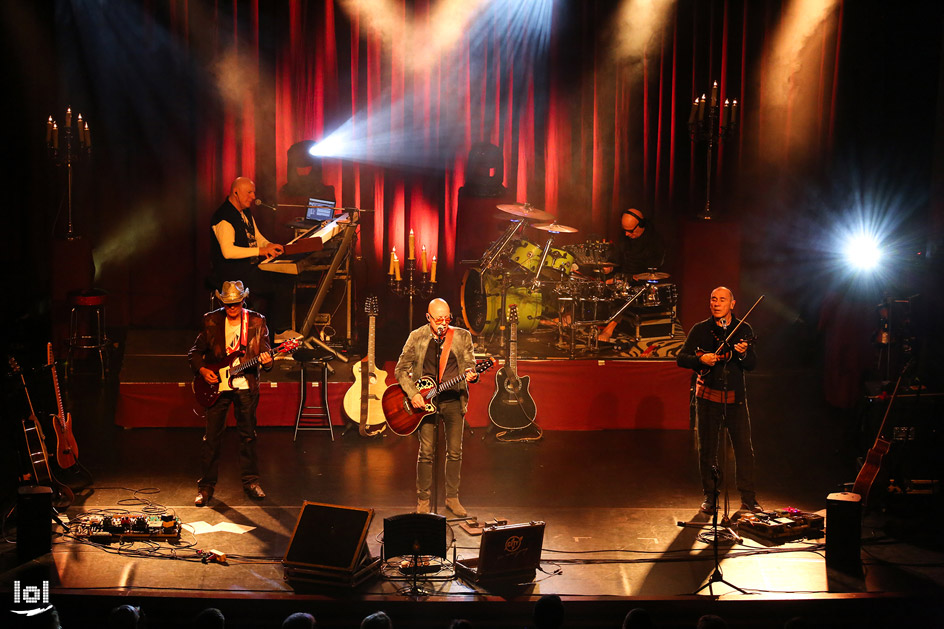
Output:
[696,398,755,504]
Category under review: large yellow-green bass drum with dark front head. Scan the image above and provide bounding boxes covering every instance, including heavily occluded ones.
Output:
[459,268,544,336]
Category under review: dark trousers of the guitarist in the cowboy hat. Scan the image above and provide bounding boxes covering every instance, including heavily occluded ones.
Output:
[197,389,259,487]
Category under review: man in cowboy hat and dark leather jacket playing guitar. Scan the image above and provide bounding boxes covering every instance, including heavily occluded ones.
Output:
[188,280,272,507]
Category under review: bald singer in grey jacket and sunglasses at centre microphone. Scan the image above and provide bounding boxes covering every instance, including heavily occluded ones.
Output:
[395,298,478,518]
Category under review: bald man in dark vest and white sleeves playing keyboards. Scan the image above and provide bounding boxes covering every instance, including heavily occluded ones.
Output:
[209,177,289,330]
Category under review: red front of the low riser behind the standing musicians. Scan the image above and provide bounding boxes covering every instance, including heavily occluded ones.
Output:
[115,360,690,430]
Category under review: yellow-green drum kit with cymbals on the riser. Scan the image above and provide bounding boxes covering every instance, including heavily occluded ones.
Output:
[460,203,678,358]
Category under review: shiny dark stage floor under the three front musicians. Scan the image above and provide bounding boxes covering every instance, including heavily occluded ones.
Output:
[2,346,944,626]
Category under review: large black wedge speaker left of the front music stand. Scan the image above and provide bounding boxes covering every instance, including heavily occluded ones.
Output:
[282,501,374,573]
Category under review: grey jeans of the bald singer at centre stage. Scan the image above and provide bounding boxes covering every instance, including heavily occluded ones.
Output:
[416,400,464,500]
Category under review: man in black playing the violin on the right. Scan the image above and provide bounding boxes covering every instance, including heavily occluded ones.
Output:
[676,286,763,514]
